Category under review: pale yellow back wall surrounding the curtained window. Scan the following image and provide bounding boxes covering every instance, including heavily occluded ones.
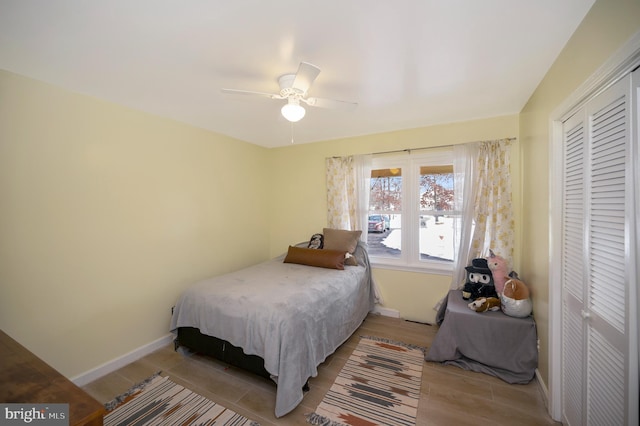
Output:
[268,115,522,323]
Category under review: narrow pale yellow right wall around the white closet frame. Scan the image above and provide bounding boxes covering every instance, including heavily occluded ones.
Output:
[520,0,640,400]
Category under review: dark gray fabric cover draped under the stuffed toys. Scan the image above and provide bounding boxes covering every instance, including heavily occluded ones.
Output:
[425,290,538,383]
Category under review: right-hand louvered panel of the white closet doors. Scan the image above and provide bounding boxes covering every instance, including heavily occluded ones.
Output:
[585,77,637,425]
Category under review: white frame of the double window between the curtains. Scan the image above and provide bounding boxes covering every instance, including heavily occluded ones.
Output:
[369,148,461,275]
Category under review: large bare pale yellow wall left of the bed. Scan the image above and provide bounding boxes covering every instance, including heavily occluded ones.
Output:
[0,71,270,377]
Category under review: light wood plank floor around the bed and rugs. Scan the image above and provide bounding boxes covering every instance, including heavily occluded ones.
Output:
[84,314,560,426]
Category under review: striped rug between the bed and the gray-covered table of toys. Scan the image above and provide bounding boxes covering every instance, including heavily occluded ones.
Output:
[307,337,424,426]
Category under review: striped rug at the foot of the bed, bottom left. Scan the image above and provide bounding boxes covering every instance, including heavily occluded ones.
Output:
[104,374,258,426]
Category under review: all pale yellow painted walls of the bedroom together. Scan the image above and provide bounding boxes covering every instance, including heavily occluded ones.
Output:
[8,0,640,380]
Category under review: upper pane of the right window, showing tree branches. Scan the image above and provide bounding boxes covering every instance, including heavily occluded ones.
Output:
[420,165,454,212]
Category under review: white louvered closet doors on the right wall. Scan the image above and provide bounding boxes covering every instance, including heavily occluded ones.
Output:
[557,70,640,426]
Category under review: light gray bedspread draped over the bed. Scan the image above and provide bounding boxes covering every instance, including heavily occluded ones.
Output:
[170,245,374,417]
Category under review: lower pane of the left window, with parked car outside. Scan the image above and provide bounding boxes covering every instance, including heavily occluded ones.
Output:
[367,214,402,258]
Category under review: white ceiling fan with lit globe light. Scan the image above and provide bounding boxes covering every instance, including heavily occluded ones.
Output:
[222,62,358,123]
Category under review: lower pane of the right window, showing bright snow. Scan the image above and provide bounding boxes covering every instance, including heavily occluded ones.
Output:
[419,215,458,262]
